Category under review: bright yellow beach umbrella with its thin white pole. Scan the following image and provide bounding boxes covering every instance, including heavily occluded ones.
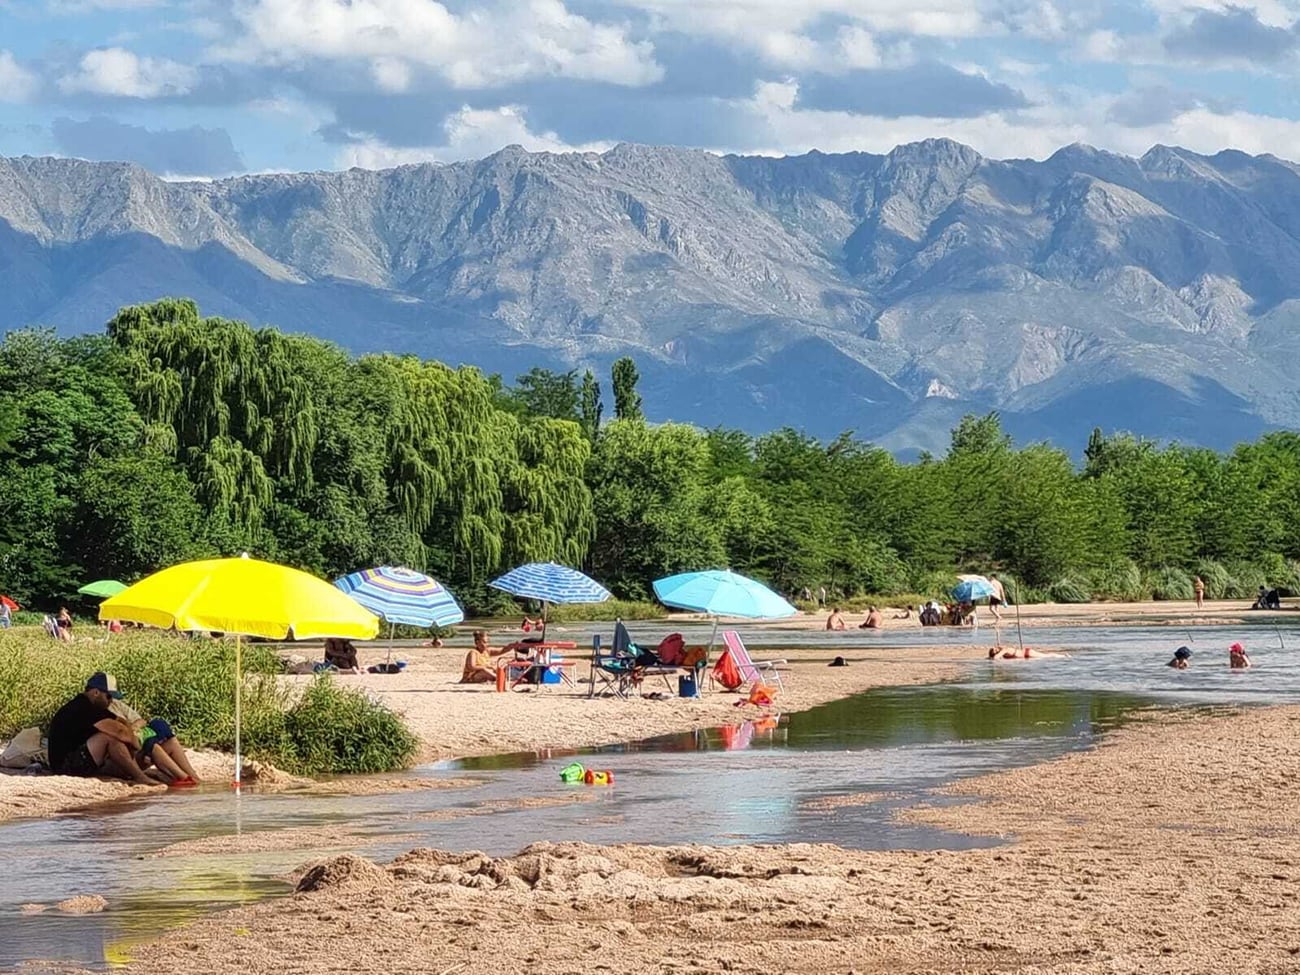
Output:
[99,558,380,788]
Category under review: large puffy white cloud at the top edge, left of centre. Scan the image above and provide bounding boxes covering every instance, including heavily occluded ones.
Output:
[216,0,663,87]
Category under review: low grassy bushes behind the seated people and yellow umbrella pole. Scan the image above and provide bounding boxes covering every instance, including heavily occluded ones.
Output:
[0,629,416,774]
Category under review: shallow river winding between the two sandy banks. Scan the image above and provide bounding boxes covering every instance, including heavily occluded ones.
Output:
[0,625,1300,967]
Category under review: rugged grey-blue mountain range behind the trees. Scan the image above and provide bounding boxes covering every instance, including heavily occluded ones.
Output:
[0,139,1300,452]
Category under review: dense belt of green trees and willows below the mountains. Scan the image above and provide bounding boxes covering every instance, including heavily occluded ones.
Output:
[0,300,1300,614]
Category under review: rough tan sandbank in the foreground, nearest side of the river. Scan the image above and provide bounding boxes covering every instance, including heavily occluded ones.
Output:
[114,707,1300,975]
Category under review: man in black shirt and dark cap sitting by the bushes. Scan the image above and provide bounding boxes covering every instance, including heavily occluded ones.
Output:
[49,672,157,785]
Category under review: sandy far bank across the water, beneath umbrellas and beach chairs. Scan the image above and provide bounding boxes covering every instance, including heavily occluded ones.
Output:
[0,592,1279,822]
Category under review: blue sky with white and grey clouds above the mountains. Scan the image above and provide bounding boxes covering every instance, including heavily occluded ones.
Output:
[0,0,1300,177]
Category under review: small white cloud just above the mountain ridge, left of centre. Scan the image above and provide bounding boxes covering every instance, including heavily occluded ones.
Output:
[338,105,610,169]
